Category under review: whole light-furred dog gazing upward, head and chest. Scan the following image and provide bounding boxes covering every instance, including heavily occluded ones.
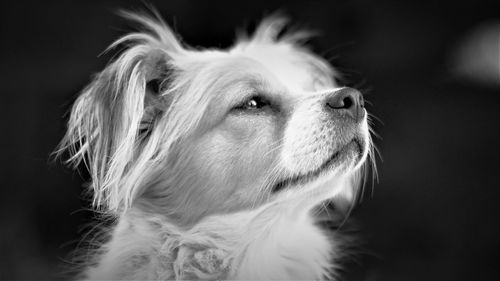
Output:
[58,9,373,280]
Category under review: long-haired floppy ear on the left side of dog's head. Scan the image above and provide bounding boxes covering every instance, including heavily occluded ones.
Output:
[58,13,183,211]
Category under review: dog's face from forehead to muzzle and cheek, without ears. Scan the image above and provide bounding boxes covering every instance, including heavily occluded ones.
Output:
[169,49,368,222]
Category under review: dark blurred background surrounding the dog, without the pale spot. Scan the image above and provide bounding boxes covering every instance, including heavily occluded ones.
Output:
[0,0,500,280]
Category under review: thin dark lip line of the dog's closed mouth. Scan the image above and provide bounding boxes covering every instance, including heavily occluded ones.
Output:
[272,137,363,192]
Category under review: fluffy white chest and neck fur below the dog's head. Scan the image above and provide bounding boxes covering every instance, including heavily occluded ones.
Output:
[86,203,335,280]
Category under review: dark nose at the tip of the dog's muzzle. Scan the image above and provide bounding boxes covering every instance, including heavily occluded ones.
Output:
[326,87,365,122]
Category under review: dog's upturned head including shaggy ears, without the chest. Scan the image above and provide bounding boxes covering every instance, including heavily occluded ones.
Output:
[61,14,370,223]
